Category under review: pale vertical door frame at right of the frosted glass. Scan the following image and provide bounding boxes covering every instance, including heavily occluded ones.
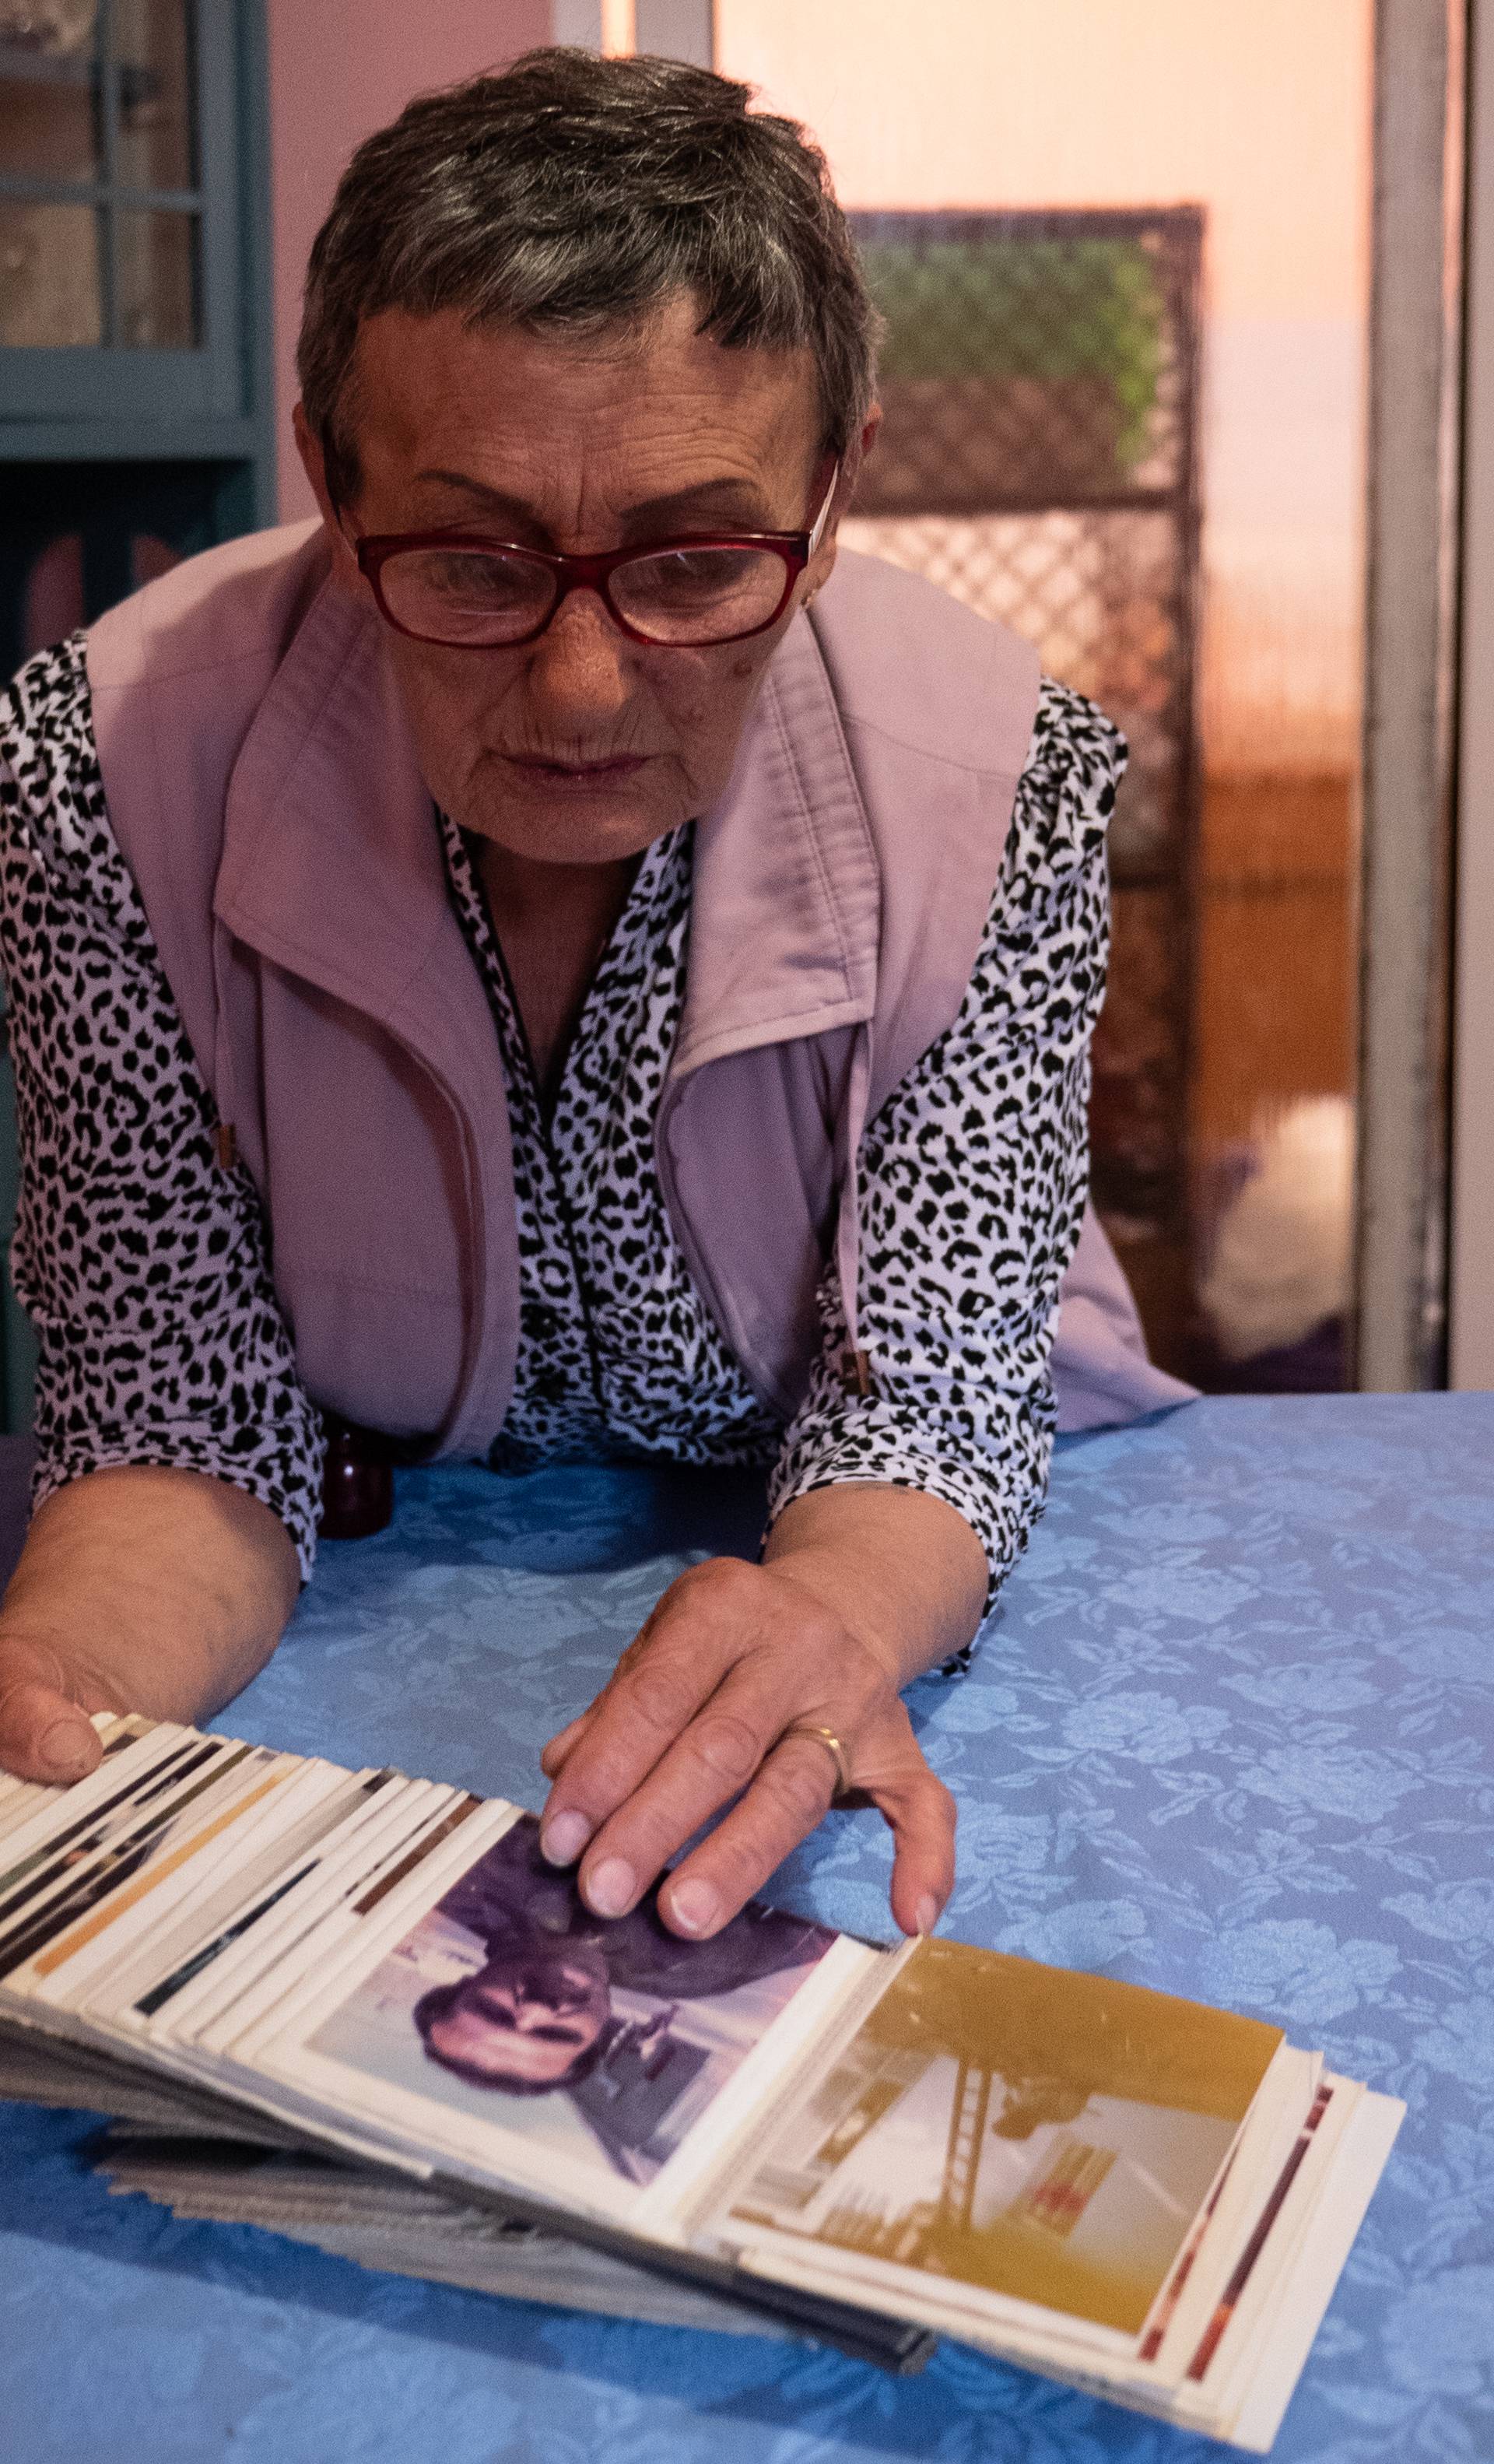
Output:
[1353,0,1467,1392]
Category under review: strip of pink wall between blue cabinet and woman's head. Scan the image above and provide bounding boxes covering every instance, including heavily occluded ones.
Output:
[268,0,550,522]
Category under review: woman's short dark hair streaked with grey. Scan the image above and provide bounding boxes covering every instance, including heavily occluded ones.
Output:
[296,49,880,503]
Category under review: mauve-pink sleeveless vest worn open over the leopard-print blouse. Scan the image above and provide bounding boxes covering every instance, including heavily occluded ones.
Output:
[89,525,1191,1454]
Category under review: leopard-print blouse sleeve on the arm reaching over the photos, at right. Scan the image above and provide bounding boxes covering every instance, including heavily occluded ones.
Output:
[770,683,1124,1671]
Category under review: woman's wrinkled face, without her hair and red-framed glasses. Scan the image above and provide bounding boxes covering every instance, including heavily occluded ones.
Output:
[303,298,833,865]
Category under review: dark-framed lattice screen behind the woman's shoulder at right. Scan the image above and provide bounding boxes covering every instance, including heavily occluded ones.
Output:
[843,207,1203,1247]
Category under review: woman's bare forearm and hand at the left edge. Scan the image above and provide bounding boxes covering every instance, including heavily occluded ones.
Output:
[0,1466,301,1781]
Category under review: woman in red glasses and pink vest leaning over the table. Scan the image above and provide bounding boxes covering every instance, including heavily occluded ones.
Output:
[0,51,1178,1936]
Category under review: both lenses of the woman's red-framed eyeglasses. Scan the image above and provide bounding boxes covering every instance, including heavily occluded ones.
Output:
[380,547,789,648]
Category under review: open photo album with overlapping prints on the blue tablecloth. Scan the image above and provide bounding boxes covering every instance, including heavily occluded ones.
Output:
[0,1715,1403,2452]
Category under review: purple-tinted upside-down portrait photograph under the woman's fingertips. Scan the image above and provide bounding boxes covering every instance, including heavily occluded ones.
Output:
[310,1813,838,2183]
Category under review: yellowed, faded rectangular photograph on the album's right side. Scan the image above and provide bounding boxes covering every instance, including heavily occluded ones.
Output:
[735,1942,1282,2333]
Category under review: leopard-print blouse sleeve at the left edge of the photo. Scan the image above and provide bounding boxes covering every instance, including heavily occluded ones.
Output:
[0,638,323,1577]
